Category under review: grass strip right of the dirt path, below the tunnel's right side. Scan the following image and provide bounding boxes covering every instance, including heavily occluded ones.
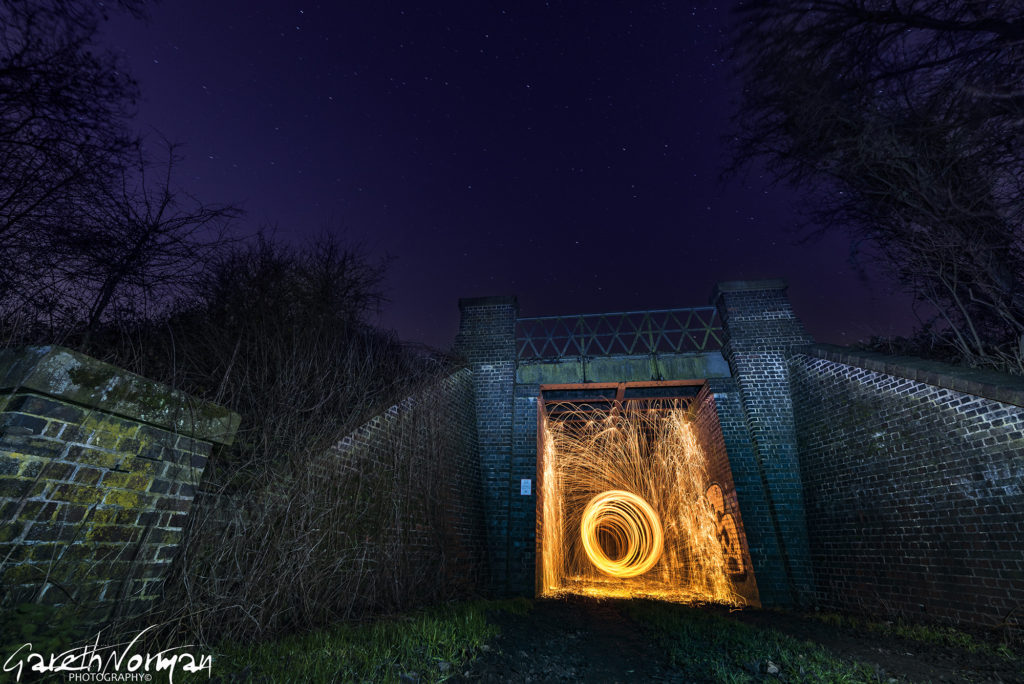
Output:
[626,601,879,684]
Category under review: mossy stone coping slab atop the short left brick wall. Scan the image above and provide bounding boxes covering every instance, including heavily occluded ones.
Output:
[0,345,242,444]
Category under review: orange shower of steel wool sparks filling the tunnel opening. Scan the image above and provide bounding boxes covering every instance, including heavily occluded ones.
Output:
[540,400,742,603]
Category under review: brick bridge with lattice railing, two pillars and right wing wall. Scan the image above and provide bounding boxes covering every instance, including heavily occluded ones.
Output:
[456,281,1024,623]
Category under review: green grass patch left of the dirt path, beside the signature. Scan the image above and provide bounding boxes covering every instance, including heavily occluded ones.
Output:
[206,599,530,684]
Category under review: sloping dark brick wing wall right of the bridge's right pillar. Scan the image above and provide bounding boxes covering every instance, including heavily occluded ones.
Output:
[790,347,1024,626]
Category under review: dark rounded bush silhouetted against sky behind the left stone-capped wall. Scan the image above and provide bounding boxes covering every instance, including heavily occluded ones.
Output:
[102,229,403,463]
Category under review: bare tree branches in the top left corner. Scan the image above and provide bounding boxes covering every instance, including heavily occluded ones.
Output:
[0,0,141,296]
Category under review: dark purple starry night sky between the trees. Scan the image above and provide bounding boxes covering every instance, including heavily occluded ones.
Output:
[106,0,911,348]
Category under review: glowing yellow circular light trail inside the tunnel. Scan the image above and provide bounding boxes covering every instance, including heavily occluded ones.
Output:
[580,489,665,578]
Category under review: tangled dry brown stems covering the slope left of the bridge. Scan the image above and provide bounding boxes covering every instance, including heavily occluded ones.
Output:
[153,370,478,642]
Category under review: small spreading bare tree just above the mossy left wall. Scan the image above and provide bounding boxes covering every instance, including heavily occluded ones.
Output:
[0,144,241,349]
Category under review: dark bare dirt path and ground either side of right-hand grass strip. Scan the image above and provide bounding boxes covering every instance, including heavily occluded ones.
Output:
[451,597,1022,684]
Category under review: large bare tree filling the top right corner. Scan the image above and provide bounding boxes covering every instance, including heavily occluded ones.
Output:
[734,0,1024,373]
